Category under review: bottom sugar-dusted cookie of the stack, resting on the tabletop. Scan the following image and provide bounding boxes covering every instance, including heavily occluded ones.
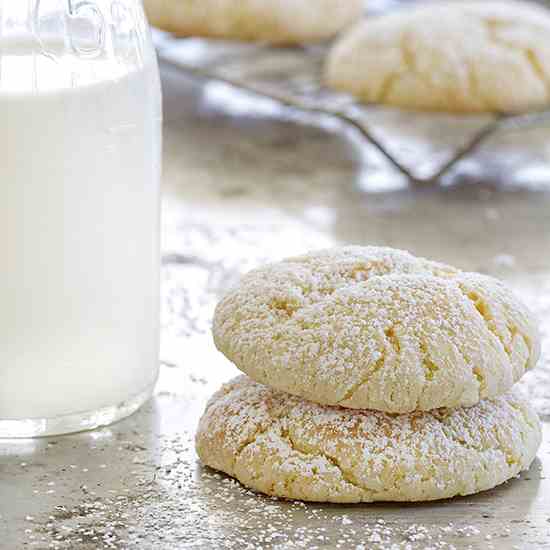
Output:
[196,376,541,502]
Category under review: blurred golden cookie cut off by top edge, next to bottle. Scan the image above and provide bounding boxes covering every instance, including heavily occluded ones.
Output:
[144,0,363,44]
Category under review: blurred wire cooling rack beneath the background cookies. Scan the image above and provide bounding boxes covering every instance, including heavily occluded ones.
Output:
[155,32,550,185]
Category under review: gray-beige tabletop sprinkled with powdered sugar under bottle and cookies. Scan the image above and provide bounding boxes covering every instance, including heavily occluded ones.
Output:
[0,61,550,550]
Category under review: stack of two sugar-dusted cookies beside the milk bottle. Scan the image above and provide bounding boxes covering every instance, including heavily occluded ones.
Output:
[196,247,541,502]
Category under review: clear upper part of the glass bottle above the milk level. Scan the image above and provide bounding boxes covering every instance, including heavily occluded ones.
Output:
[0,0,158,96]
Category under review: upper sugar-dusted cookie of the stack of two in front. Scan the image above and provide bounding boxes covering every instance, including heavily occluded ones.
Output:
[213,246,540,413]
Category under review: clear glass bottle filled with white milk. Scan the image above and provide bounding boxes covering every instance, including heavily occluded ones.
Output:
[0,0,161,437]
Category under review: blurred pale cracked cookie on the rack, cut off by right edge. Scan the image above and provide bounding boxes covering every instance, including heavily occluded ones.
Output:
[325,1,550,113]
